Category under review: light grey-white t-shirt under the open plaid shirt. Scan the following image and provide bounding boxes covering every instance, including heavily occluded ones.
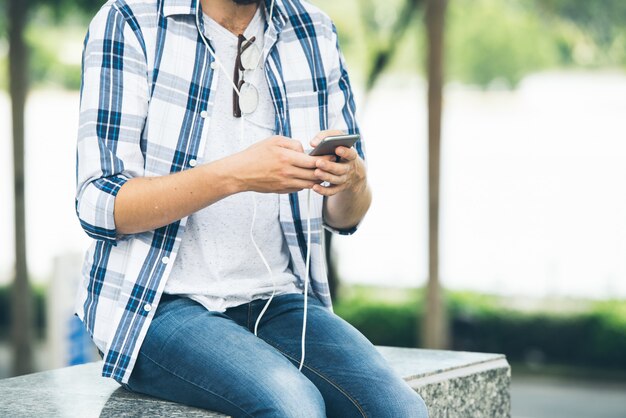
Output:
[165,8,301,312]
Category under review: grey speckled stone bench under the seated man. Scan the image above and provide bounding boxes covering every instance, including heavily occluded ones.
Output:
[0,347,511,418]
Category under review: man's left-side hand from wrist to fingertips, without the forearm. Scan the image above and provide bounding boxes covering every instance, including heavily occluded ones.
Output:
[230,136,334,193]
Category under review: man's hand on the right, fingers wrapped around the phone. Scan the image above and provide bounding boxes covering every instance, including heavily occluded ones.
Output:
[311,131,367,196]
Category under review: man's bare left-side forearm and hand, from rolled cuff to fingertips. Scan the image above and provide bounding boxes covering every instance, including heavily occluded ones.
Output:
[114,136,334,234]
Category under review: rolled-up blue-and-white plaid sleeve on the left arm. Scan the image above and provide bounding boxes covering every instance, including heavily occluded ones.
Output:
[75,4,149,244]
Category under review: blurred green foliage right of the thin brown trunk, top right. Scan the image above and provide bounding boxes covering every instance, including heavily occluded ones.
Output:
[446,0,626,87]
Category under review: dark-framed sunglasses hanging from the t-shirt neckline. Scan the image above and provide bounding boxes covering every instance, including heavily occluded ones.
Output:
[233,35,261,118]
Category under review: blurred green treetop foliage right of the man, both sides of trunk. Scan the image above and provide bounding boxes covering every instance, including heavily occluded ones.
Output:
[316,0,626,88]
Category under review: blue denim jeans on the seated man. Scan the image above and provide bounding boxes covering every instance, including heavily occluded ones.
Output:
[125,294,428,418]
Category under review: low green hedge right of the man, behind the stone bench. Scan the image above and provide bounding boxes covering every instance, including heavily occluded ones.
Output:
[335,290,626,371]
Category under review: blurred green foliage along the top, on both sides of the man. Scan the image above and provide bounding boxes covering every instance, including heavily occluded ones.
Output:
[0,0,626,89]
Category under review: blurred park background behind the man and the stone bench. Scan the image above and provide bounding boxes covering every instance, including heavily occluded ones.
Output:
[0,0,626,418]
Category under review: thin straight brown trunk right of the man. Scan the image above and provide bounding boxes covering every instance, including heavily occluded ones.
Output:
[421,0,449,349]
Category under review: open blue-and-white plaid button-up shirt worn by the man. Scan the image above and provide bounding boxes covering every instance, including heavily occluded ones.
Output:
[75,0,364,383]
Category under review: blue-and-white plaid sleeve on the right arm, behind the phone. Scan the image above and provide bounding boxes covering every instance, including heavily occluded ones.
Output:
[324,25,366,235]
